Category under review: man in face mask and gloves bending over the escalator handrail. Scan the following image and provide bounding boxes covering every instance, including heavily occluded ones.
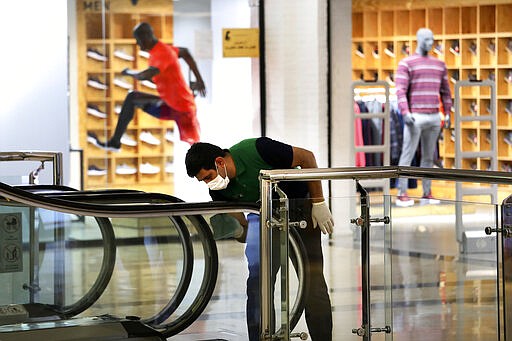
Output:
[185,137,334,341]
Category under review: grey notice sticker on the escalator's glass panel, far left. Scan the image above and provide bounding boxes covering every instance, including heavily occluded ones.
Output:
[0,213,23,272]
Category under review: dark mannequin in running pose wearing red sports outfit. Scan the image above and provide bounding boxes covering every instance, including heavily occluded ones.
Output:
[88,22,206,151]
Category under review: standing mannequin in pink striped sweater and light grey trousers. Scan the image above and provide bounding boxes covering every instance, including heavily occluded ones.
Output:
[395,28,452,206]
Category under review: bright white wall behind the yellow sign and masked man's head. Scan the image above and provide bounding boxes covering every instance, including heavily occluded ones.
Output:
[174,0,259,202]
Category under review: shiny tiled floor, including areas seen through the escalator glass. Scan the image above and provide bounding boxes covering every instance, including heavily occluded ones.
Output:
[0,198,503,341]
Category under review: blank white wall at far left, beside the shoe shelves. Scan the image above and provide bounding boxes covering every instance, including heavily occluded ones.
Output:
[0,0,69,183]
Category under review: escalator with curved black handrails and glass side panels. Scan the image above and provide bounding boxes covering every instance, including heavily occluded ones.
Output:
[0,183,308,340]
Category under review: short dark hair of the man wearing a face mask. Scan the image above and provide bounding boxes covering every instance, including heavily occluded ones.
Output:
[185,142,227,178]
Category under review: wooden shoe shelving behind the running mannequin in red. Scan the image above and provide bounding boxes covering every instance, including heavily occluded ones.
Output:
[77,0,175,194]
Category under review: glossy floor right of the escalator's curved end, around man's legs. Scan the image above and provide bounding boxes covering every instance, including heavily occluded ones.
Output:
[172,199,503,341]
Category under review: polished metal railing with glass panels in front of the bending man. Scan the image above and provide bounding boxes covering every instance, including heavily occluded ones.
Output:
[260,166,512,340]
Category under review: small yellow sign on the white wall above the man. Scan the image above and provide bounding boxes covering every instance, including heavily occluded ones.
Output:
[222,28,260,57]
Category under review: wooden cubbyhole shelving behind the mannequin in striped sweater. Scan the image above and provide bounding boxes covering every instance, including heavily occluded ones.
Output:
[352,0,512,171]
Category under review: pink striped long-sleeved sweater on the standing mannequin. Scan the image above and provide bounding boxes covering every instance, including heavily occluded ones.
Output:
[395,53,452,115]
